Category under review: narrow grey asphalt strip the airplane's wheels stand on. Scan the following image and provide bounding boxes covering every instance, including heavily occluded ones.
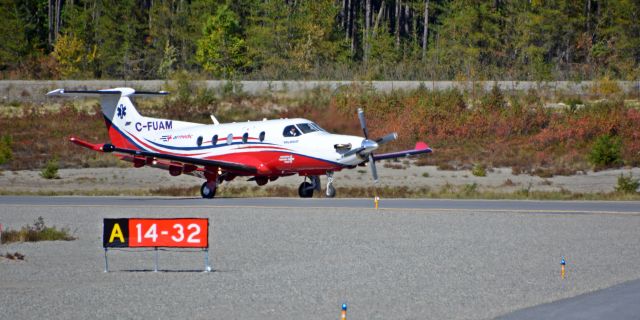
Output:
[0,196,640,214]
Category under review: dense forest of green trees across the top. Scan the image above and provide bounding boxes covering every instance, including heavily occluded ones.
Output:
[0,0,640,81]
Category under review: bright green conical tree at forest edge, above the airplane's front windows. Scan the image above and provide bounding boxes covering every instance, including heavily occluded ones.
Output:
[196,5,249,78]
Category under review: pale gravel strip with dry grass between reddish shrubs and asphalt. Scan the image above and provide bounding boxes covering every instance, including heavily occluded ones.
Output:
[0,164,640,195]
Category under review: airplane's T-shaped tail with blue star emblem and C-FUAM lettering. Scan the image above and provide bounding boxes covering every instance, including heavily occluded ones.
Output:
[47,88,196,150]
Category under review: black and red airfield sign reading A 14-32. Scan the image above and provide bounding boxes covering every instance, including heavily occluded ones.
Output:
[102,218,209,248]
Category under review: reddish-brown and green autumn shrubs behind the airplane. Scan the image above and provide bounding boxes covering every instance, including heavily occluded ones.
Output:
[0,85,640,175]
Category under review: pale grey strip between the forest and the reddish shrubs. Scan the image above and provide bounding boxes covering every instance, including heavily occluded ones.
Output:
[0,80,640,104]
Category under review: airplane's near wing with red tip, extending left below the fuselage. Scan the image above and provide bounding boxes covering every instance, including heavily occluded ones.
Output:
[70,137,258,174]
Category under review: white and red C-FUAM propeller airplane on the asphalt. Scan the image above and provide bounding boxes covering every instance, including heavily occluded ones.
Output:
[47,88,431,198]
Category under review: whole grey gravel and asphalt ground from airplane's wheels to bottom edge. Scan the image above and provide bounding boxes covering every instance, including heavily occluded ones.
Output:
[0,196,640,319]
